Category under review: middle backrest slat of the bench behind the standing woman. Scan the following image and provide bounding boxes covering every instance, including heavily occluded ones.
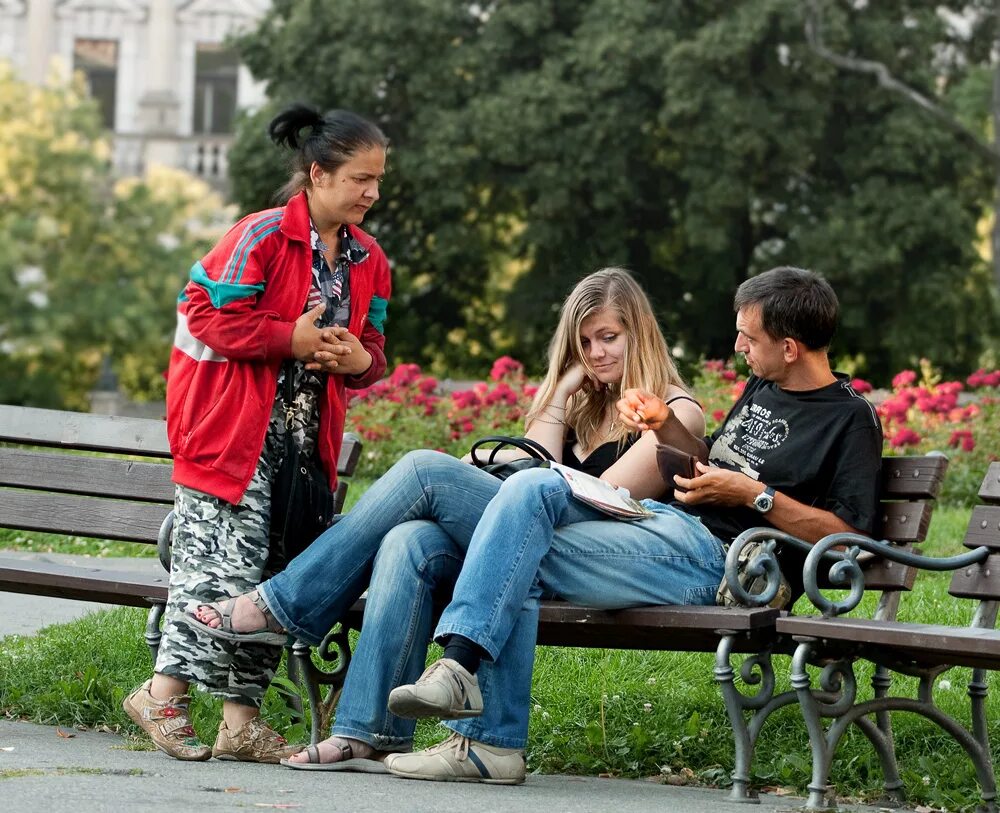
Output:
[0,449,174,503]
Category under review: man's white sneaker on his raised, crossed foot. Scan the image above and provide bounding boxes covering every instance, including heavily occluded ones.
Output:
[389,658,483,720]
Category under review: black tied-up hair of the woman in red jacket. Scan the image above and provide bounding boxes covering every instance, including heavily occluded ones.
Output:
[267,103,389,203]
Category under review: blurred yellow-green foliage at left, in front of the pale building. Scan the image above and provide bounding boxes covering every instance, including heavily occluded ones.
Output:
[0,64,232,409]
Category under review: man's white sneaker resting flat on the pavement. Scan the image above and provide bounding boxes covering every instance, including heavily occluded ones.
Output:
[385,732,525,785]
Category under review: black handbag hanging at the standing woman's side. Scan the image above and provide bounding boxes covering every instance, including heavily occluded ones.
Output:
[267,362,335,573]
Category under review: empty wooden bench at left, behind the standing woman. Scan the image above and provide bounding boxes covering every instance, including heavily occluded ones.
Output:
[0,405,361,659]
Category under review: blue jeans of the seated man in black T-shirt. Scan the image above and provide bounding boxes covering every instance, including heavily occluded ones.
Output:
[436,470,725,748]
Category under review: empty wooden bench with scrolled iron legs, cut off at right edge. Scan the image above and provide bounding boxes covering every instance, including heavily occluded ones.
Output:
[764,463,1000,813]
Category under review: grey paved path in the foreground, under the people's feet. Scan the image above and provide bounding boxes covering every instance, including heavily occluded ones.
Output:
[0,721,896,813]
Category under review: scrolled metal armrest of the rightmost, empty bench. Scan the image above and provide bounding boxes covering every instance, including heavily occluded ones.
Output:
[802,533,989,616]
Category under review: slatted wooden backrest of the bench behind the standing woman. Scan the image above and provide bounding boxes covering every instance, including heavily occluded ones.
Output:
[0,405,361,544]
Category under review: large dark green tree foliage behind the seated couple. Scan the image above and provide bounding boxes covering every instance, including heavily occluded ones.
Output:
[232,0,997,377]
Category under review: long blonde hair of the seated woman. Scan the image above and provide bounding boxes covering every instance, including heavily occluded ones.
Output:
[526,268,687,450]
